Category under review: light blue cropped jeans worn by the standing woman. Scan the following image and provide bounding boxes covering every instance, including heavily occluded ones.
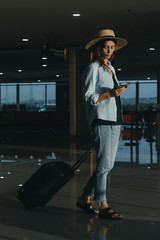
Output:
[84,125,120,202]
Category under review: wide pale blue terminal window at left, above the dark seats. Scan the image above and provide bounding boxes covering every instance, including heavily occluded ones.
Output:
[0,82,56,112]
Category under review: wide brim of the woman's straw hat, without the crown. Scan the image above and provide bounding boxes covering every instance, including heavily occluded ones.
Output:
[86,36,128,51]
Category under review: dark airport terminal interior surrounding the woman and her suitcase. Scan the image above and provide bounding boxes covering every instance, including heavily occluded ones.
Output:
[0,0,160,240]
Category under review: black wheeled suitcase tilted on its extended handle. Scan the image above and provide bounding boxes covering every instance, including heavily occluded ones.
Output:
[16,146,93,210]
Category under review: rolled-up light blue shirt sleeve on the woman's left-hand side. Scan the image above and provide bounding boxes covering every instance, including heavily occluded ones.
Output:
[82,63,99,106]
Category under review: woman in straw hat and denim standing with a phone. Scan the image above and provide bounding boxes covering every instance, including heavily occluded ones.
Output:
[76,29,127,219]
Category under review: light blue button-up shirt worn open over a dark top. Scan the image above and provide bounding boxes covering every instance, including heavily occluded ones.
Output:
[82,61,119,125]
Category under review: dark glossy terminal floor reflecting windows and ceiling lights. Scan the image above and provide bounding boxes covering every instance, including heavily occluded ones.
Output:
[0,126,160,240]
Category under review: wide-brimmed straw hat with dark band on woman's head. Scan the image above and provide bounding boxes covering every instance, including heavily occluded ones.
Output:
[86,29,128,51]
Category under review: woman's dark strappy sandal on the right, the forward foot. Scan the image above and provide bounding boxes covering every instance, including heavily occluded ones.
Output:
[99,207,122,220]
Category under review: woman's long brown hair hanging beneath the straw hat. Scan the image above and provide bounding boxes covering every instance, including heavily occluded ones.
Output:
[90,39,116,66]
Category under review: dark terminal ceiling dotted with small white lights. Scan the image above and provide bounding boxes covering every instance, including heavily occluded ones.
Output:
[0,0,160,82]
